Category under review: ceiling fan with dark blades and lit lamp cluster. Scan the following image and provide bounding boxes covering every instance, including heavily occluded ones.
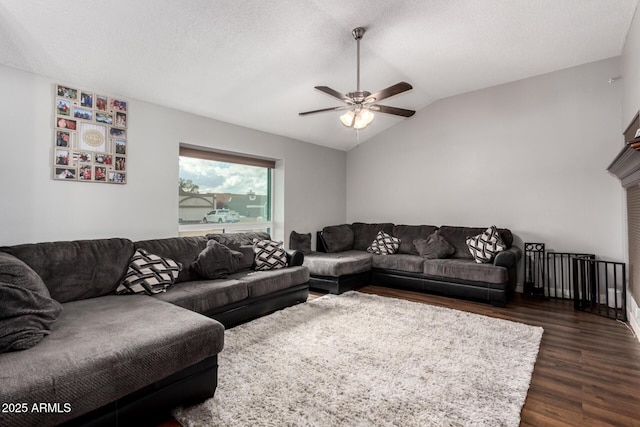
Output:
[298,27,416,130]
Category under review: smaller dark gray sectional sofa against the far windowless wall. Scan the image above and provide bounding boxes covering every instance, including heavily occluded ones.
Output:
[304,222,522,306]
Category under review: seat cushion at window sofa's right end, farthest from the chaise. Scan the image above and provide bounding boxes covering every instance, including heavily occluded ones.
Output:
[229,267,309,298]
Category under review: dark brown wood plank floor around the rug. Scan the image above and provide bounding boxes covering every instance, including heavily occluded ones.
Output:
[162,286,640,427]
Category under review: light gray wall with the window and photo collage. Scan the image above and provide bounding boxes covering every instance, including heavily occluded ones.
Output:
[0,66,346,249]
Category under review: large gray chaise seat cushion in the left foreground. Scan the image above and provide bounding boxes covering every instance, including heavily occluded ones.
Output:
[0,295,224,426]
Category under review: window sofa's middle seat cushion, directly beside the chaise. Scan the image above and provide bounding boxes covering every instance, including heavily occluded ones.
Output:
[154,279,249,315]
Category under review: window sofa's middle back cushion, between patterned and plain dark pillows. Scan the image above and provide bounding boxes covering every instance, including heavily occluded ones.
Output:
[134,236,207,283]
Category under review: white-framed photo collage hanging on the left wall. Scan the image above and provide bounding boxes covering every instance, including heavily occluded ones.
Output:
[52,85,129,184]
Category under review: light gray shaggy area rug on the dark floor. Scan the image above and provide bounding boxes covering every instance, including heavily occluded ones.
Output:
[173,292,543,427]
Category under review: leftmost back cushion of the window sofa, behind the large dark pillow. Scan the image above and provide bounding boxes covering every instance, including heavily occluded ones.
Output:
[0,238,133,302]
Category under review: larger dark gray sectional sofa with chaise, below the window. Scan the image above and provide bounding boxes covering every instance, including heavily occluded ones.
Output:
[0,233,309,426]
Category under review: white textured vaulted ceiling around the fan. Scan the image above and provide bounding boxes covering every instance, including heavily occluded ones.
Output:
[0,0,638,150]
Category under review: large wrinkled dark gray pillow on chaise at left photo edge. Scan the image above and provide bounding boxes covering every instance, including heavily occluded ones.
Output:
[0,253,62,353]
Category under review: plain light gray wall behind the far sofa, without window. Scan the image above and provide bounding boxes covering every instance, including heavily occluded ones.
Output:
[347,58,623,260]
